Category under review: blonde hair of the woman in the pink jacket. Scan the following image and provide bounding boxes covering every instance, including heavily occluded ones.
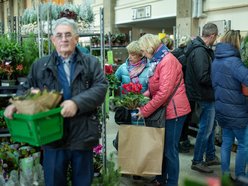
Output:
[139,34,161,54]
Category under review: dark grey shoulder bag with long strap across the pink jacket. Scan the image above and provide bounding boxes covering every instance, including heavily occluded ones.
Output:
[145,76,183,127]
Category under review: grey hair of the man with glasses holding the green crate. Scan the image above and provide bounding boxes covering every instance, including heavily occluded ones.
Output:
[52,17,78,35]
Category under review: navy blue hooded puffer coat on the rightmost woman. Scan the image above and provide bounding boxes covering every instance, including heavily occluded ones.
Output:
[212,43,248,128]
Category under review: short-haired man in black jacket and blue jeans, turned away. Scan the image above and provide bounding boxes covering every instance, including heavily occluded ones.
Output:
[185,23,220,173]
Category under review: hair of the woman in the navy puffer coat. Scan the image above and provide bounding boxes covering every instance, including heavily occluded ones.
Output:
[220,30,241,50]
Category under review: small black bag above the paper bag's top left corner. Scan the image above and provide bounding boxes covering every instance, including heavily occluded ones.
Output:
[114,107,131,125]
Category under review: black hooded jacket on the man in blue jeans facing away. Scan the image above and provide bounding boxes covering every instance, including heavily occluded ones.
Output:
[185,37,214,102]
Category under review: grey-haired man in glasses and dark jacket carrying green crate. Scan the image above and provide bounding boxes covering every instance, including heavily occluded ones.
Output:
[5,18,108,186]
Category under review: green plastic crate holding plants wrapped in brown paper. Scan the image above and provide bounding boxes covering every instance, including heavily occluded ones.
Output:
[5,90,63,146]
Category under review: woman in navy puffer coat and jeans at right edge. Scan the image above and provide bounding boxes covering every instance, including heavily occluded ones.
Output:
[212,30,248,177]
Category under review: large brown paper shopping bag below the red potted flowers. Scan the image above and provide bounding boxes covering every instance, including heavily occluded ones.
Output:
[118,125,165,176]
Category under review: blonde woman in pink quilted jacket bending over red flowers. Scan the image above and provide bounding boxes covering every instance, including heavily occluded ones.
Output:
[138,34,191,186]
